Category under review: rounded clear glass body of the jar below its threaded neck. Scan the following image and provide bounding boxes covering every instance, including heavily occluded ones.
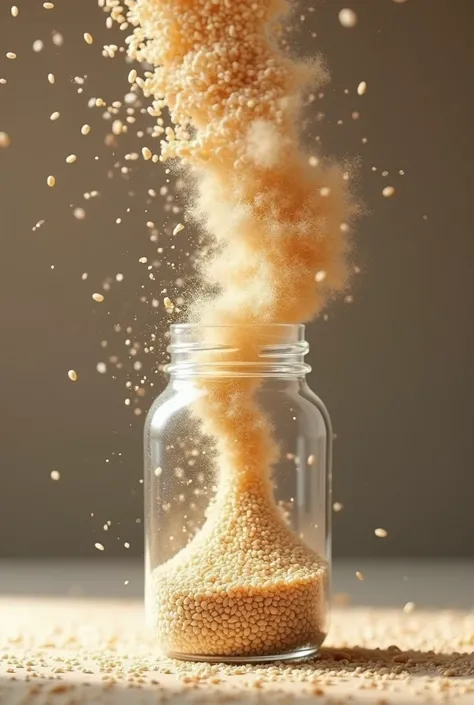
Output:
[144,374,332,662]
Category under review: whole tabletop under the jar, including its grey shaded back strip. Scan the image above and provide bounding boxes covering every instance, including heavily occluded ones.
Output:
[0,561,474,705]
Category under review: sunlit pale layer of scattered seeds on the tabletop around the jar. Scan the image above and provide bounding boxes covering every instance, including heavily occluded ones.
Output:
[0,598,474,705]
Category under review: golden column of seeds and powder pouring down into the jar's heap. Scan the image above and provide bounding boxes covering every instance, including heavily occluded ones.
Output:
[104,0,357,656]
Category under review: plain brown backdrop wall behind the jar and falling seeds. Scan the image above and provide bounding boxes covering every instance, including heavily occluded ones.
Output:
[0,0,474,558]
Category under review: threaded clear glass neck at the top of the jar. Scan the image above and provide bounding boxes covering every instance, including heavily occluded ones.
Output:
[165,323,311,377]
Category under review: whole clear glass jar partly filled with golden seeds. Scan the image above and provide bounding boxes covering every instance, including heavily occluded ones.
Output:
[144,324,332,663]
